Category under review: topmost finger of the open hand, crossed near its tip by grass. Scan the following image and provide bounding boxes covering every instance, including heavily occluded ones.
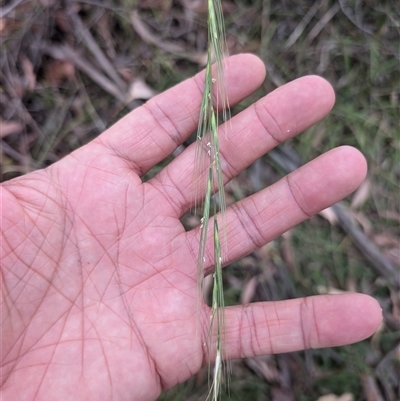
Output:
[98,54,265,174]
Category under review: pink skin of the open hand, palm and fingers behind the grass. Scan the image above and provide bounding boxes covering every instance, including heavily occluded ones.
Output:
[1,55,381,401]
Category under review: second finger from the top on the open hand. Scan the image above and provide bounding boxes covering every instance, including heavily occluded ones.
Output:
[150,72,335,216]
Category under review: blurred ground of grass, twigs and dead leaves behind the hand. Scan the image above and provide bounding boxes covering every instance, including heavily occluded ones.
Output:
[0,0,400,401]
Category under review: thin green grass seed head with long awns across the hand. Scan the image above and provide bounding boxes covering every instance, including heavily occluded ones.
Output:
[195,0,229,401]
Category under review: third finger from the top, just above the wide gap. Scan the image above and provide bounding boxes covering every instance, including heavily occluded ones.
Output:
[186,146,367,272]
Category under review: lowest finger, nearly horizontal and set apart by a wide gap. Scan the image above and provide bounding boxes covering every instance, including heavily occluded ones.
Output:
[205,294,382,362]
